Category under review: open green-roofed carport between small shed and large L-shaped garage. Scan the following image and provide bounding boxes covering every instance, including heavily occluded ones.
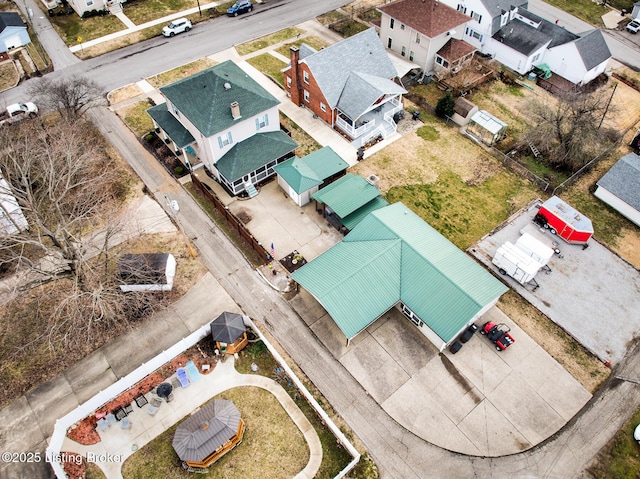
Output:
[311,173,389,231]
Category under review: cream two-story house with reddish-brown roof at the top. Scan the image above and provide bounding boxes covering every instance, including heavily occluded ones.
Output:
[378,0,476,74]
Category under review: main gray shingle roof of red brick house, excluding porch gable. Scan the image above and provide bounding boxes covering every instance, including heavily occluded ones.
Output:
[302,28,397,108]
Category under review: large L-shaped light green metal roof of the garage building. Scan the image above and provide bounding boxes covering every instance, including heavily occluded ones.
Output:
[291,203,507,343]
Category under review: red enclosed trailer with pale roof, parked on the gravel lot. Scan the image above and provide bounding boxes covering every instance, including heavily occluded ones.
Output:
[534,196,593,245]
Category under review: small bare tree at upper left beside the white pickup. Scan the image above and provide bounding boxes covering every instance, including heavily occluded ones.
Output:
[29,77,102,121]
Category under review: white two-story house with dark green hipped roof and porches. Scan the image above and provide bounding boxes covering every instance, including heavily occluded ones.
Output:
[147,60,298,195]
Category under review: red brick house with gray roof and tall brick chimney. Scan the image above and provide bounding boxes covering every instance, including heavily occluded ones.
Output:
[283,28,406,146]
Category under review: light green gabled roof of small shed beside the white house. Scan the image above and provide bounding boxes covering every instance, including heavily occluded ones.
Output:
[274,146,349,194]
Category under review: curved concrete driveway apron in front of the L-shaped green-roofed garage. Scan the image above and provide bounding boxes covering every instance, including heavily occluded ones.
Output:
[291,290,591,457]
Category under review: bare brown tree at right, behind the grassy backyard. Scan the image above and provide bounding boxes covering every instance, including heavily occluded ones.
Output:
[525,89,612,171]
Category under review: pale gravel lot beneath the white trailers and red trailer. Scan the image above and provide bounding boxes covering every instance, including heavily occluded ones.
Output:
[470,203,640,363]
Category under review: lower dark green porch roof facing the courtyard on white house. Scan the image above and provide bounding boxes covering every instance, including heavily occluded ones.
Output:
[216,130,298,183]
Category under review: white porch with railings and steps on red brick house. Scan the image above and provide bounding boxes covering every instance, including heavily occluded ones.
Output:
[335,96,402,148]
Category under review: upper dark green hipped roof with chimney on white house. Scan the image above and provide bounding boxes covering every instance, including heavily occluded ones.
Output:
[160,60,280,137]
